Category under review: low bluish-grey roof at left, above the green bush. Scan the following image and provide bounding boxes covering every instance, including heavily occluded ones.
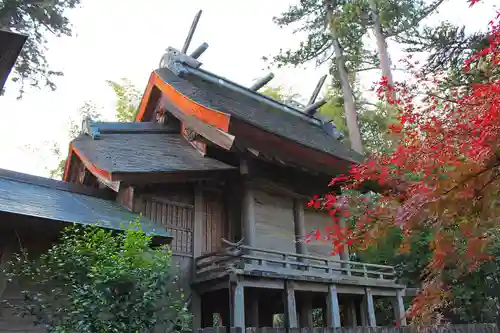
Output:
[0,169,171,238]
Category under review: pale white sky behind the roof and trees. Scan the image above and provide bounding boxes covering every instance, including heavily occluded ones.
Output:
[0,0,496,176]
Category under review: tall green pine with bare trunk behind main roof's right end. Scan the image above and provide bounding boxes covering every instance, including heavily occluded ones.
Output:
[274,0,443,152]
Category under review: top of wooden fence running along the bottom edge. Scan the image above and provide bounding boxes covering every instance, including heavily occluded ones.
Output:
[190,324,498,333]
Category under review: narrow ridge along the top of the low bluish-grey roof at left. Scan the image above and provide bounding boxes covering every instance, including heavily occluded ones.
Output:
[0,169,110,199]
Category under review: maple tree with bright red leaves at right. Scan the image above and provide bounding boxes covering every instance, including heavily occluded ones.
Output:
[309,0,500,325]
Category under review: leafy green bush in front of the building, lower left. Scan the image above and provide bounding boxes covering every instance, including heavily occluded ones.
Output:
[6,224,191,333]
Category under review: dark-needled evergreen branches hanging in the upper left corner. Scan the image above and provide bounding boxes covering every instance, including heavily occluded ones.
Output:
[0,0,80,97]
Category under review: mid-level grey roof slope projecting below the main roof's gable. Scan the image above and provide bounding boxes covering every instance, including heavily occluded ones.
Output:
[73,129,235,175]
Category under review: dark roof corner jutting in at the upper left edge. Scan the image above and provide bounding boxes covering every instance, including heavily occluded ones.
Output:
[0,30,27,91]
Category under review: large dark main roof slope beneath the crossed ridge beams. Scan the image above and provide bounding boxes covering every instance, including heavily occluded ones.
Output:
[155,68,362,162]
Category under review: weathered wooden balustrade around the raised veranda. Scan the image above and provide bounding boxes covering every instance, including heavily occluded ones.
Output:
[195,240,396,282]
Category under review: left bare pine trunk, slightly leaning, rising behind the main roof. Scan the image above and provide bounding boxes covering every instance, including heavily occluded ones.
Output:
[326,1,363,154]
